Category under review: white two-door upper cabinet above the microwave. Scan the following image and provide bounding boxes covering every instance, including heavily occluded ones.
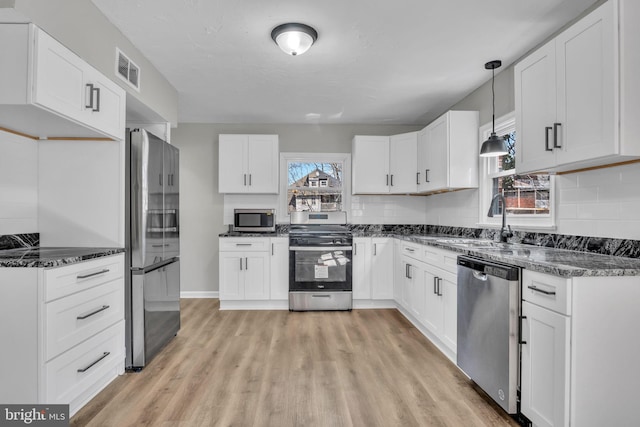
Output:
[218,134,279,194]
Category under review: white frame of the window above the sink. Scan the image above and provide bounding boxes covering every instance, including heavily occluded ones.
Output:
[478,112,556,230]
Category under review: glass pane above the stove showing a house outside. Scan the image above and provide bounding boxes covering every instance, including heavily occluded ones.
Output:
[287,162,343,212]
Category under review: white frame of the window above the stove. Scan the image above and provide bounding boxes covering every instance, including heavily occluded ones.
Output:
[277,153,351,224]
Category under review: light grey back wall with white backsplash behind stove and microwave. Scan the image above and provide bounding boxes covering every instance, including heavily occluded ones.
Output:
[171,123,425,292]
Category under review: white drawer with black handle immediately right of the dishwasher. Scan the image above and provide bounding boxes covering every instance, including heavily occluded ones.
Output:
[522,269,572,315]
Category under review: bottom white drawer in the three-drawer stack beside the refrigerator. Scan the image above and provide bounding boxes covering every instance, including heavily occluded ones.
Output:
[43,321,125,413]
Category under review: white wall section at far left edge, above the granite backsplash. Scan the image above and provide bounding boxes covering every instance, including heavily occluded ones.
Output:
[0,131,38,235]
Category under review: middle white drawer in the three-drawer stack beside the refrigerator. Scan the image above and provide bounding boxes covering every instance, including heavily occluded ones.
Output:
[44,279,124,360]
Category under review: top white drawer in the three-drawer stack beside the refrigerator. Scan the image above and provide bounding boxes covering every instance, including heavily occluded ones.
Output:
[43,254,124,301]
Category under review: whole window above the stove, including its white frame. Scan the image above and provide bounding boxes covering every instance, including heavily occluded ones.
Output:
[279,153,351,221]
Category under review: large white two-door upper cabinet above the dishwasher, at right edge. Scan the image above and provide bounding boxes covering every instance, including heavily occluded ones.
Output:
[514,0,640,173]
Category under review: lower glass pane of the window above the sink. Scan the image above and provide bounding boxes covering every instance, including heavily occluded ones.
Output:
[493,174,550,215]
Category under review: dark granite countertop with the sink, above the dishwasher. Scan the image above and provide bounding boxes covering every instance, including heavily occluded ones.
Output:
[389,235,640,277]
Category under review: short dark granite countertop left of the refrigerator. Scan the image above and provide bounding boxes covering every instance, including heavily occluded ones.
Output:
[0,247,124,268]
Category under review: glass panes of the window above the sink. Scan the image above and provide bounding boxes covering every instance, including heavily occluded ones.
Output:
[488,130,551,215]
